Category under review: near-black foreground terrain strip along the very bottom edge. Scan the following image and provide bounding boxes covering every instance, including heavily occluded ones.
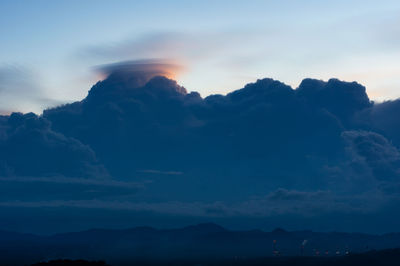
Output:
[28,249,400,266]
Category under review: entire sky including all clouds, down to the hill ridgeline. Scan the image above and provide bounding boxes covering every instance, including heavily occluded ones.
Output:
[0,1,400,233]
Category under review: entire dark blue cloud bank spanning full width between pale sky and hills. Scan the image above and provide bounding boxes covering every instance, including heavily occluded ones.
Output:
[0,71,400,231]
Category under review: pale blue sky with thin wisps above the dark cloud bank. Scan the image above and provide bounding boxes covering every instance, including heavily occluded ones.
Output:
[0,1,400,113]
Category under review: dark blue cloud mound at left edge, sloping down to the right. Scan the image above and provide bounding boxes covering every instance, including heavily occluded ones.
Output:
[0,113,108,178]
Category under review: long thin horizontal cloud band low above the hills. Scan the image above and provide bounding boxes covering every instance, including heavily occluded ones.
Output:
[0,189,390,217]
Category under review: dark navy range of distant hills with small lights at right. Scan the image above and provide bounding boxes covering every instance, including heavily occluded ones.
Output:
[0,223,400,264]
